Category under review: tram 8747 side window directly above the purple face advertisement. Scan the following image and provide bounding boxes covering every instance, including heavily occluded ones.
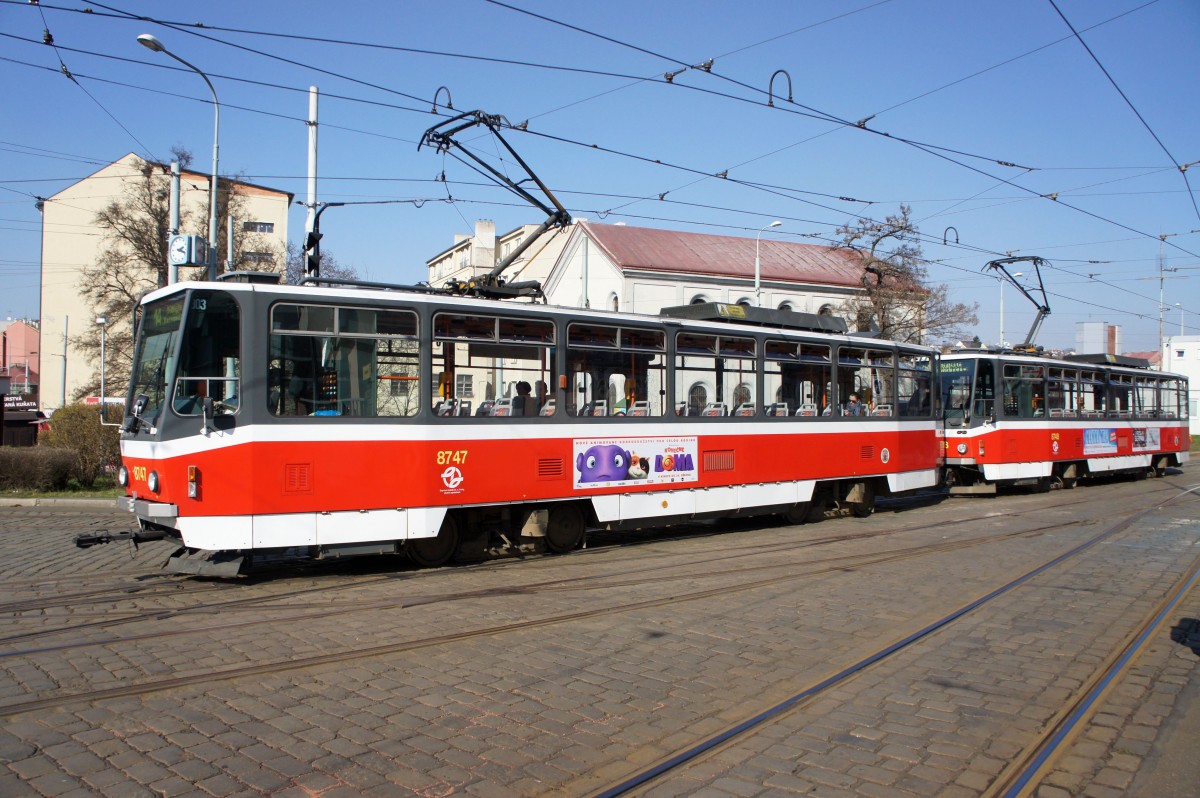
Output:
[565,324,667,418]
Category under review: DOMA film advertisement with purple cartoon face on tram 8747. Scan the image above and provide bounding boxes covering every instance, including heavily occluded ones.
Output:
[574,437,698,488]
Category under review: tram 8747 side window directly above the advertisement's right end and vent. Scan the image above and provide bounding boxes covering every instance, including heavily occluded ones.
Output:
[674,332,760,416]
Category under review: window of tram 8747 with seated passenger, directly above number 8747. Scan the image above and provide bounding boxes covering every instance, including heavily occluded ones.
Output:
[430,313,556,419]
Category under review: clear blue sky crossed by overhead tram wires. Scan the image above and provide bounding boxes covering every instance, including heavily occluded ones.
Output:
[0,0,1200,350]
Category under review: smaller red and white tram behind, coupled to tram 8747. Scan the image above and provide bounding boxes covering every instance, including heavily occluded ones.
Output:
[940,350,1190,493]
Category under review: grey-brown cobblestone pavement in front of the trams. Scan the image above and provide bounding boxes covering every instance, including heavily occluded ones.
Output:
[0,472,1200,798]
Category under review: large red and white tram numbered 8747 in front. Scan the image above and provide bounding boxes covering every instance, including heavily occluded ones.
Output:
[121,276,945,572]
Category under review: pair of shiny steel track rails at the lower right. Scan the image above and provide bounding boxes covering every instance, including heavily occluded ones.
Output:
[592,486,1200,798]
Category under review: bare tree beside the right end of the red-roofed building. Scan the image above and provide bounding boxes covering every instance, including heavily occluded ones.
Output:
[838,205,979,343]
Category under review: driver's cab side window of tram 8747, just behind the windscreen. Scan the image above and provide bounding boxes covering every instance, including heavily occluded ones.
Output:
[172,290,241,415]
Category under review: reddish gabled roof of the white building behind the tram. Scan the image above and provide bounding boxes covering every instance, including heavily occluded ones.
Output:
[578,222,863,288]
